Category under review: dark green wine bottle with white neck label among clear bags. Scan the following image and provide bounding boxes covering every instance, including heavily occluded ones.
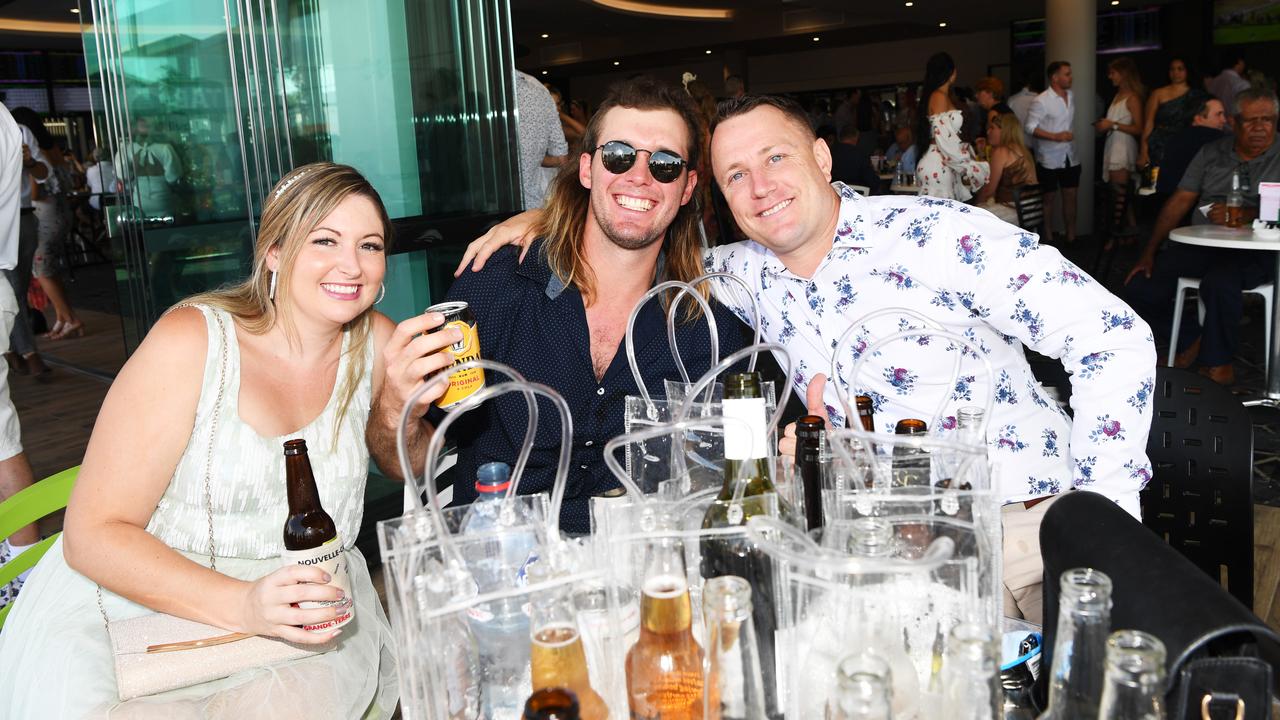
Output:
[701,373,799,717]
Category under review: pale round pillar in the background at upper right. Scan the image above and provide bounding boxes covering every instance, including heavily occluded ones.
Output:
[1044,0,1098,234]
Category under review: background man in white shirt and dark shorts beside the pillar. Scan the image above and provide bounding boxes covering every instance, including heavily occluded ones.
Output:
[1023,60,1080,243]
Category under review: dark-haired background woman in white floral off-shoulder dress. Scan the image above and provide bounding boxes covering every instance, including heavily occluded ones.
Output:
[915,53,991,201]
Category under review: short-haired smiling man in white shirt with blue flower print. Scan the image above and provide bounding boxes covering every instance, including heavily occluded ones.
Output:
[707,96,1156,620]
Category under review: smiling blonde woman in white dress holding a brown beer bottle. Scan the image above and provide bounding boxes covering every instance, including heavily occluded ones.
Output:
[0,163,457,719]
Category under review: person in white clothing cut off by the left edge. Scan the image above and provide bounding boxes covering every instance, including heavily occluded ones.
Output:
[0,105,47,607]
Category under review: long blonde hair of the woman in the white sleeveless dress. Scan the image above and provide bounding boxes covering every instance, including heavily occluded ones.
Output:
[175,163,392,432]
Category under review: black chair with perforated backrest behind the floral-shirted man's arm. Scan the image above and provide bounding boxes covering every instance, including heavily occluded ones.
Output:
[1142,368,1253,607]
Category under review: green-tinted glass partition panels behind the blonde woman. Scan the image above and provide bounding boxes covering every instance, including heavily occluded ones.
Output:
[81,0,520,350]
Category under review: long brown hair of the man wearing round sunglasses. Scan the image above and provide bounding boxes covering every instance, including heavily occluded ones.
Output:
[536,76,709,319]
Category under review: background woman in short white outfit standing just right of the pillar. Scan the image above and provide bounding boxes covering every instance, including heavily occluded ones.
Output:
[1093,56,1147,240]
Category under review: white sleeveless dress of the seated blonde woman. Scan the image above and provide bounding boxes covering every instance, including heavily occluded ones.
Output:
[0,307,399,720]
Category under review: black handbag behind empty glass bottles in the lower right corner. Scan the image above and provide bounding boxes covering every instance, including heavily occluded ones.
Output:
[1036,491,1280,720]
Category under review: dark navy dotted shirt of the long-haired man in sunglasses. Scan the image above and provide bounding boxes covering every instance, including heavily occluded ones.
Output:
[448,241,750,533]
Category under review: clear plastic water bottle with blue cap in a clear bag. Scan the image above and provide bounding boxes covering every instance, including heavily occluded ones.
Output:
[461,462,538,720]
